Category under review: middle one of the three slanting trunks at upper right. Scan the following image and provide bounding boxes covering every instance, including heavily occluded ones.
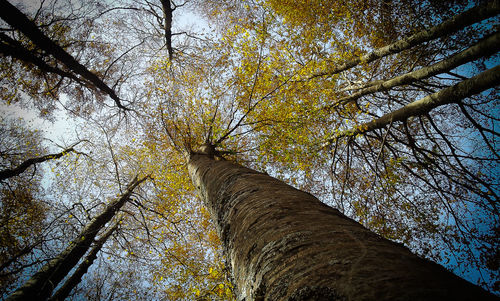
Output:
[333,33,500,106]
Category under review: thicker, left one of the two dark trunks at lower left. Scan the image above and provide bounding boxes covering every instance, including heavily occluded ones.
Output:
[6,177,146,301]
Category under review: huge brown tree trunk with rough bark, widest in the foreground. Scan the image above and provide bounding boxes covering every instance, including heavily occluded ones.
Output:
[188,145,496,300]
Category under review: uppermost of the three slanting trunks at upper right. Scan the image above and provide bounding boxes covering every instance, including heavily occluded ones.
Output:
[313,0,500,77]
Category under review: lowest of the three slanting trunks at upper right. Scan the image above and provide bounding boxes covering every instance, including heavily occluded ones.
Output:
[323,65,500,147]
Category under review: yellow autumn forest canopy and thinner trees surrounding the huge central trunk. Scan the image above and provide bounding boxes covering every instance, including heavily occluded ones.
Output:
[0,0,500,300]
